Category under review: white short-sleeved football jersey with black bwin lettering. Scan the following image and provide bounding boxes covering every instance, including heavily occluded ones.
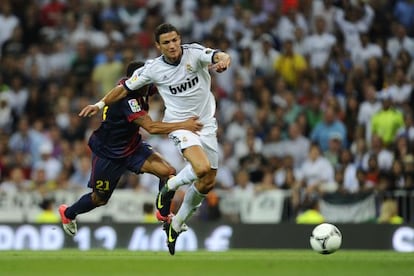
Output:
[125,44,216,125]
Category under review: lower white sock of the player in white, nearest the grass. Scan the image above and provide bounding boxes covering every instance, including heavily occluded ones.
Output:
[172,184,206,229]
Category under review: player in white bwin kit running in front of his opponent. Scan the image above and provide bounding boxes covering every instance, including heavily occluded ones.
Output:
[79,24,231,255]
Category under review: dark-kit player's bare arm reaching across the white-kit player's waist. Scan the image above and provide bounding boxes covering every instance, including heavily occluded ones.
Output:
[134,115,203,134]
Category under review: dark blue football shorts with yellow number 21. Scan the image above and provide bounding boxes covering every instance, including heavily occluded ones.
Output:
[88,141,154,199]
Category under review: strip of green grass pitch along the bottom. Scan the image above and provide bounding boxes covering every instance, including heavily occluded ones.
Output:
[0,250,414,276]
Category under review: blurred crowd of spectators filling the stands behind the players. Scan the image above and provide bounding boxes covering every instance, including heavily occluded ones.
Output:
[0,0,414,223]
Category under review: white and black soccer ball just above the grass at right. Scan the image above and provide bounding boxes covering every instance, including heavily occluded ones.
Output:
[310,223,342,254]
